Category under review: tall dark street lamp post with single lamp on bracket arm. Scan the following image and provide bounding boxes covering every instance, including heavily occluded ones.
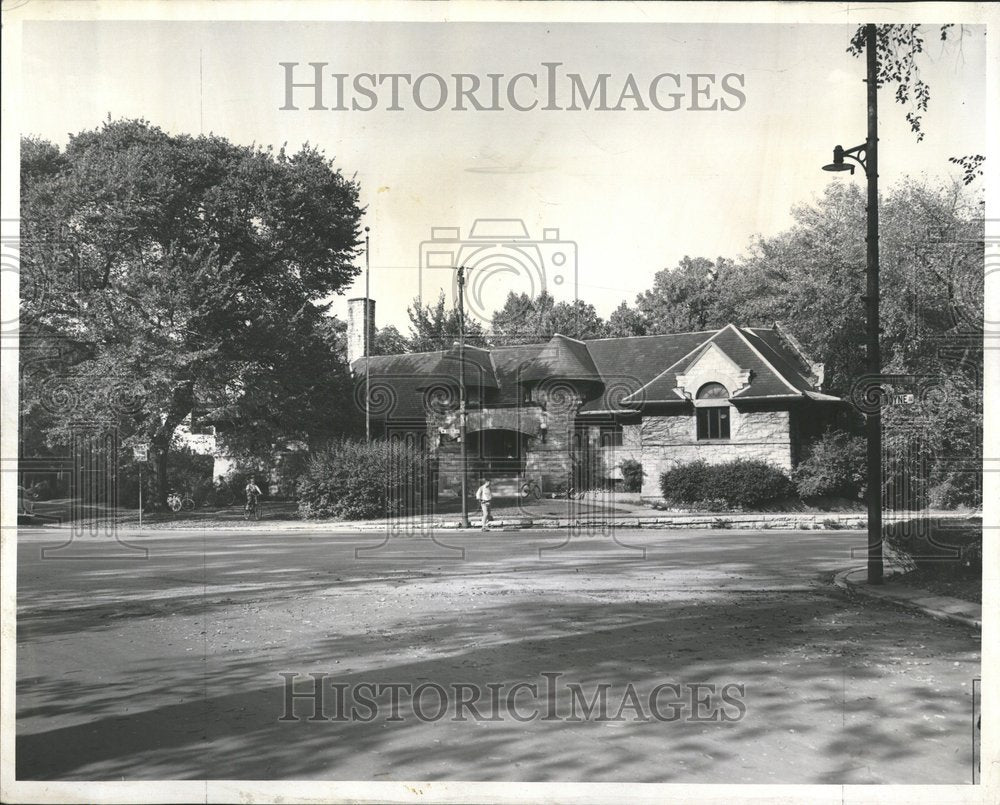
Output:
[823,24,882,584]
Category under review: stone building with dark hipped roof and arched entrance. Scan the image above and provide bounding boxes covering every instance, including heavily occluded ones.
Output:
[349,300,842,498]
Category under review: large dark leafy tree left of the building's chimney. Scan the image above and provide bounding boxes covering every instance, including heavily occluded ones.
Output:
[21,120,361,501]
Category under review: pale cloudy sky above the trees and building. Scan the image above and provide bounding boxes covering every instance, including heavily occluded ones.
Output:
[20,21,986,332]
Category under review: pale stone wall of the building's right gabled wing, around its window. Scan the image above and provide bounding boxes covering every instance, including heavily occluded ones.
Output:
[633,407,792,498]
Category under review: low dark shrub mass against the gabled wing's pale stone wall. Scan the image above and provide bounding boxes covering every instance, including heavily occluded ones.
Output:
[660,459,795,509]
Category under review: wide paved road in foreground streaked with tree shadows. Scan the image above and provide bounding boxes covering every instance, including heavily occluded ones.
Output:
[16,530,979,783]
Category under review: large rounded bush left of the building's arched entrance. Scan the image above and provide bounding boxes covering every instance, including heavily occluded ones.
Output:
[297,440,427,520]
